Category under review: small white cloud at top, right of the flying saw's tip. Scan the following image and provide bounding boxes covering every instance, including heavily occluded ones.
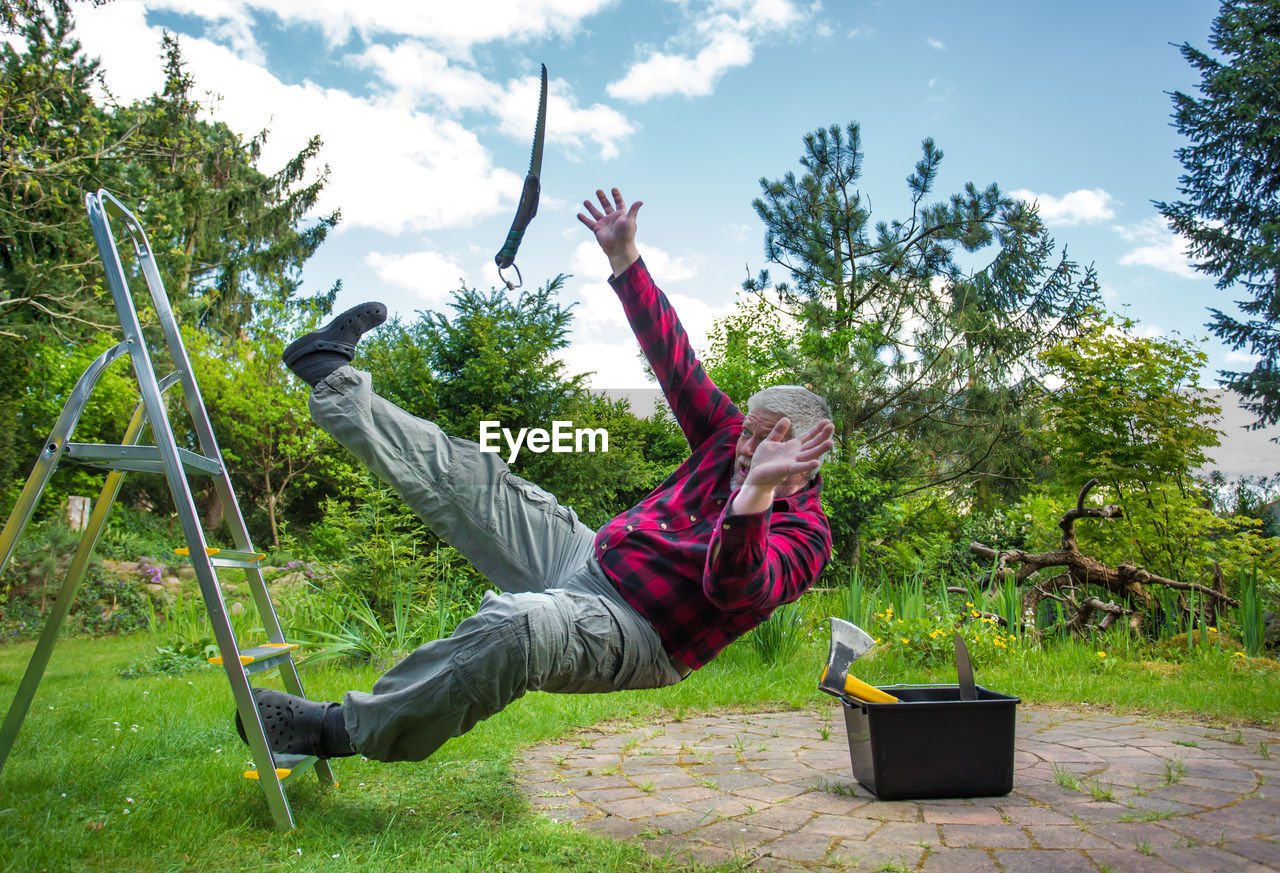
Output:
[605,0,820,102]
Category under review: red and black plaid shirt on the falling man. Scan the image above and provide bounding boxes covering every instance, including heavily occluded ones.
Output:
[595,261,831,669]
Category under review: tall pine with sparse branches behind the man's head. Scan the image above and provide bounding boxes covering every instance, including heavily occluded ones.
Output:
[745,123,1098,557]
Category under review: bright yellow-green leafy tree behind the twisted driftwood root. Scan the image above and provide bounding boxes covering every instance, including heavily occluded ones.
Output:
[1029,320,1275,581]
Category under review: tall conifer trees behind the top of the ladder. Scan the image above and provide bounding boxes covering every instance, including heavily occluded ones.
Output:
[0,0,338,514]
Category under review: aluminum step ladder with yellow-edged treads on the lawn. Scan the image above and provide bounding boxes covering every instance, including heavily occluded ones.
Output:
[0,189,337,828]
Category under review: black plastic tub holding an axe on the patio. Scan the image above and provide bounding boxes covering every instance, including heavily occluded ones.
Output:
[845,685,1020,800]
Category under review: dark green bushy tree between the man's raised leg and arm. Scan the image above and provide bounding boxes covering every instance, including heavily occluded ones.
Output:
[357,276,687,526]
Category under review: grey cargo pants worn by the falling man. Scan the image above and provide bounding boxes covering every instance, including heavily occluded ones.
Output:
[310,366,681,760]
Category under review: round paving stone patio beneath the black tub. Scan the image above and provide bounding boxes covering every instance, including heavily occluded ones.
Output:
[521,701,1280,873]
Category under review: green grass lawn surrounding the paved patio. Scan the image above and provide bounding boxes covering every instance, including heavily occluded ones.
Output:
[0,631,1280,873]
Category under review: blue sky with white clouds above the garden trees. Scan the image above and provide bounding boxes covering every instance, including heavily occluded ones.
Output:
[57,0,1280,472]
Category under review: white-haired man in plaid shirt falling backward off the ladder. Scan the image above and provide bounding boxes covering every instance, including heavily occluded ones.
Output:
[241,188,833,760]
